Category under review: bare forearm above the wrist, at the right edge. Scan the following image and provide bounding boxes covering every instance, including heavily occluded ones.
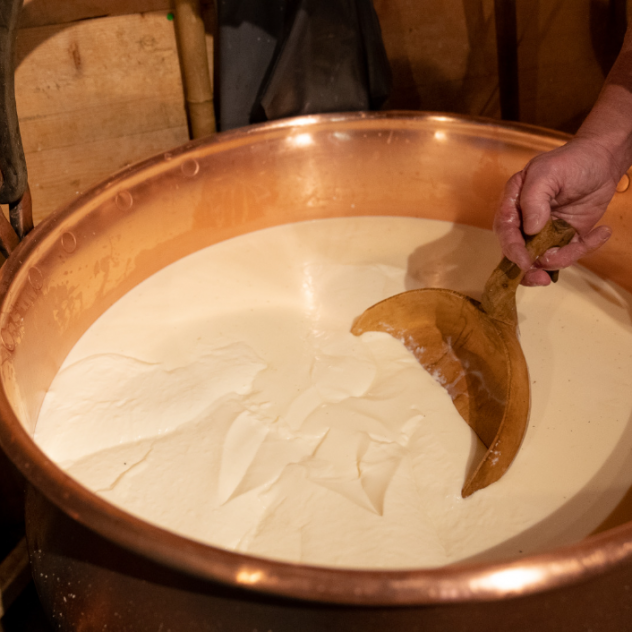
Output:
[576,27,632,179]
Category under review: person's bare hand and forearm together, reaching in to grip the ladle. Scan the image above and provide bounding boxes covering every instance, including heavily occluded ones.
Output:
[494,27,632,285]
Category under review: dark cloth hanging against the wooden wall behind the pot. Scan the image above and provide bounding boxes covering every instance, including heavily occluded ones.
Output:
[216,0,391,130]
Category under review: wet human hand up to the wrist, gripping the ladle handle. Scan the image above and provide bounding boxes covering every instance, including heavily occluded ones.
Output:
[494,137,621,285]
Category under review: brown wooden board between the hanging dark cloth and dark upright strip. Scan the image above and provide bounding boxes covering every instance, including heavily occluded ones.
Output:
[374,0,500,116]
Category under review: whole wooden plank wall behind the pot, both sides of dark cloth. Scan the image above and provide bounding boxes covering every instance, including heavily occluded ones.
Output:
[7,0,628,222]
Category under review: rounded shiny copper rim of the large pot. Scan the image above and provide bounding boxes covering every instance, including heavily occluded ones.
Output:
[0,112,632,606]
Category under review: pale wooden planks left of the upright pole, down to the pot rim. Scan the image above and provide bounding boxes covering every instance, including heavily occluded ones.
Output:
[16,11,188,222]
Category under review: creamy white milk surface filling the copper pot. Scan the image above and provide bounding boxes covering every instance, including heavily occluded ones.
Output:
[35,217,632,568]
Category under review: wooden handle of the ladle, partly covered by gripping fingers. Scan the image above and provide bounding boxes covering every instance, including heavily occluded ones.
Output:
[481,219,575,326]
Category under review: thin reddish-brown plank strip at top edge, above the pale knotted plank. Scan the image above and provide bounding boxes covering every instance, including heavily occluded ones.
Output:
[20,0,171,28]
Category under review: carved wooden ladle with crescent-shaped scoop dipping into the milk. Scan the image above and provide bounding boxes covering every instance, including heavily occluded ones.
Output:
[351,220,575,498]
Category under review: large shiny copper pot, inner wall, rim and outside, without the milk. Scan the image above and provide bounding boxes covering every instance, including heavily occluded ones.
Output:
[0,113,632,632]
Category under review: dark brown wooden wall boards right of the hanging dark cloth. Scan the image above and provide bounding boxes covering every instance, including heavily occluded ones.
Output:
[374,0,632,132]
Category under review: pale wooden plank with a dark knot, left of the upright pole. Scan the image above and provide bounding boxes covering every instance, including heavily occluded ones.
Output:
[16,12,182,119]
